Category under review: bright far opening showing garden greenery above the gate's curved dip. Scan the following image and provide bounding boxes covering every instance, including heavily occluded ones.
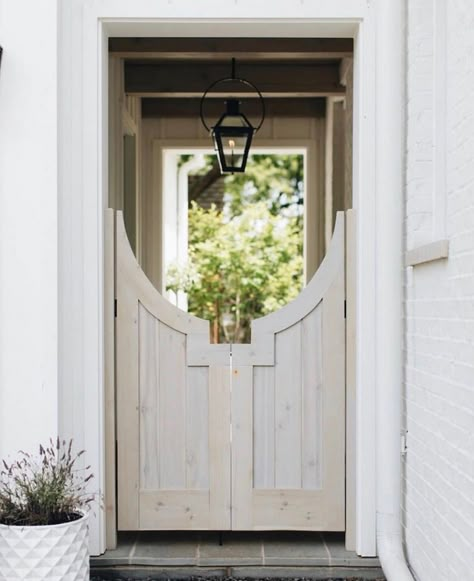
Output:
[163,148,307,343]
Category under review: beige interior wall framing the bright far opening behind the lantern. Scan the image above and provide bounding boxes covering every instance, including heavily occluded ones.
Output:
[141,118,325,290]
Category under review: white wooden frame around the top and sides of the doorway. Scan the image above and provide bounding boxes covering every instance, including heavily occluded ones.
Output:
[59,0,386,556]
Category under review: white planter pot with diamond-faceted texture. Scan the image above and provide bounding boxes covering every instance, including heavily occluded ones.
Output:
[0,514,89,581]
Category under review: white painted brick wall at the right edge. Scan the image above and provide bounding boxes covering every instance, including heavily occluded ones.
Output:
[403,0,474,581]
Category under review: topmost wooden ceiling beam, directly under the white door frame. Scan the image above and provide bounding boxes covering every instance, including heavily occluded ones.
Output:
[109,38,354,61]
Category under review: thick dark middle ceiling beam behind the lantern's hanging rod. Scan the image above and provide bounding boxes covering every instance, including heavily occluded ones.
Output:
[125,61,345,97]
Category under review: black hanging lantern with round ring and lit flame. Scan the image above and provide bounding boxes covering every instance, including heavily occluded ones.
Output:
[200,59,265,173]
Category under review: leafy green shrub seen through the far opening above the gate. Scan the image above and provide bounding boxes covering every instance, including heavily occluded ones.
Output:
[167,201,303,342]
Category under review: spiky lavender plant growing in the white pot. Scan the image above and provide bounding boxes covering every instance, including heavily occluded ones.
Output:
[0,438,93,526]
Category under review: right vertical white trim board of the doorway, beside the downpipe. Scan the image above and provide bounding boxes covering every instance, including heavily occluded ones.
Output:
[353,4,378,556]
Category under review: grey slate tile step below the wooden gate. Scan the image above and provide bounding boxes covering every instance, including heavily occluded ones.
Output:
[91,532,383,579]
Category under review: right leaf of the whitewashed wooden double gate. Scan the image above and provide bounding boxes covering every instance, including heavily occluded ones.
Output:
[232,213,345,531]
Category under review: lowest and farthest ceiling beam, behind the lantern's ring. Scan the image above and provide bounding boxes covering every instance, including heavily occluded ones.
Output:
[142,98,326,122]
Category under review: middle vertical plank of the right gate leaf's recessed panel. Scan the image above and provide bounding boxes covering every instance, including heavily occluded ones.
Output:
[275,323,302,488]
